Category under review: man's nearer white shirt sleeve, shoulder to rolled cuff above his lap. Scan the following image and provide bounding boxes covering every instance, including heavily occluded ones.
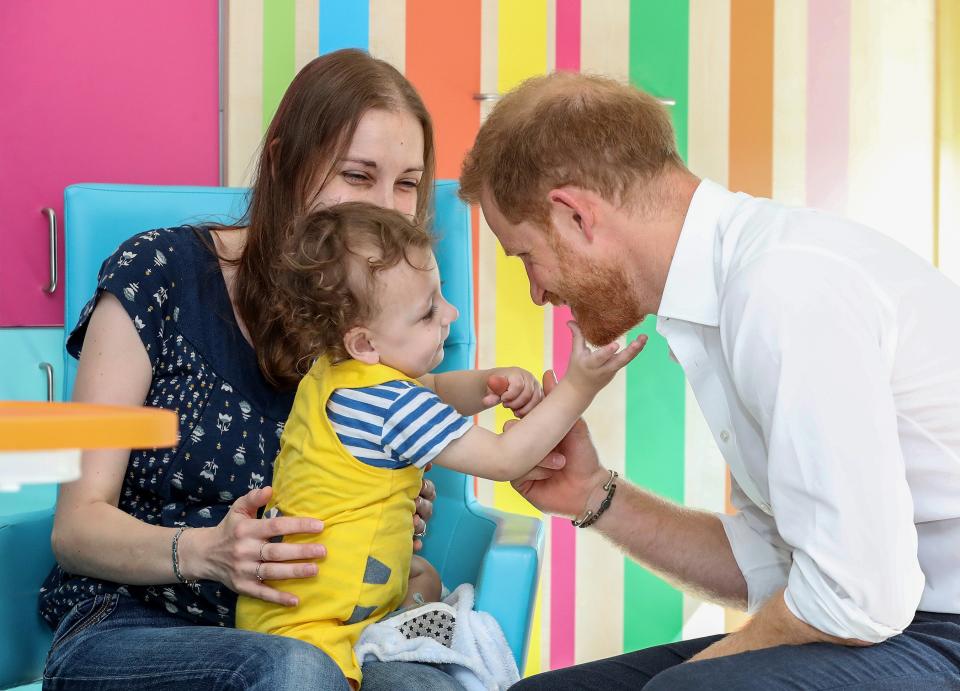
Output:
[720,250,924,643]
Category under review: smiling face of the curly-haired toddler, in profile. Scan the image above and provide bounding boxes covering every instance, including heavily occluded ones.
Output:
[367,250,459,378]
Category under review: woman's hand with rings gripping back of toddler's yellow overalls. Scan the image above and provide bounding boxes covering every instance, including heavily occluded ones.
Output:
[180,487,327,607]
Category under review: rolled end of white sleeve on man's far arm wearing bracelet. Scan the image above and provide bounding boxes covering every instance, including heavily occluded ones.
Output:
[717,480,790,614]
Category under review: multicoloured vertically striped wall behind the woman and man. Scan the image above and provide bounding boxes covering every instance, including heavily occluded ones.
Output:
[225,0,960,673]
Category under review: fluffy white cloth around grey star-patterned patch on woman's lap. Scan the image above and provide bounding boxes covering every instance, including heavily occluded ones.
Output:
[354,583,520,691]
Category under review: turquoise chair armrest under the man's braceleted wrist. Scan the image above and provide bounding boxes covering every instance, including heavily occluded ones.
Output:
[476,507,543,676]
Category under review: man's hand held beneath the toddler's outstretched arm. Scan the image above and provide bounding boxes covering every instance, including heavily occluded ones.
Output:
[505,370,609,517]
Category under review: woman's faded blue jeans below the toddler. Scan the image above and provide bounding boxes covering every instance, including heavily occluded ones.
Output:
[43,595,462,691]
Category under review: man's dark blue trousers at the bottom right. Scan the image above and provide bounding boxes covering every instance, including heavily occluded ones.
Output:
[513,612,960,691]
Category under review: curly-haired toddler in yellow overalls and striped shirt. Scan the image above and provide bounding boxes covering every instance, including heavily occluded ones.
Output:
[237,202,641,688]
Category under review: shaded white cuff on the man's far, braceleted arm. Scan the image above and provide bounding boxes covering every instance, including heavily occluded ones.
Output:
[714,513,790,614]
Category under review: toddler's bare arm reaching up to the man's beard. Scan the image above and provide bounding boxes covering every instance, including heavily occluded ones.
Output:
[434,322,646,480]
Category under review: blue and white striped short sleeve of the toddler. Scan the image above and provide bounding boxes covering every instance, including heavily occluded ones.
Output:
[381,382,473,468]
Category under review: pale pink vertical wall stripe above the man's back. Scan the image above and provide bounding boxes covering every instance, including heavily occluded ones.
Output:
[806,0,850,213]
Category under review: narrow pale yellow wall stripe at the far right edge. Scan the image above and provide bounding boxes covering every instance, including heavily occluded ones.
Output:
[934,0,960,283]
